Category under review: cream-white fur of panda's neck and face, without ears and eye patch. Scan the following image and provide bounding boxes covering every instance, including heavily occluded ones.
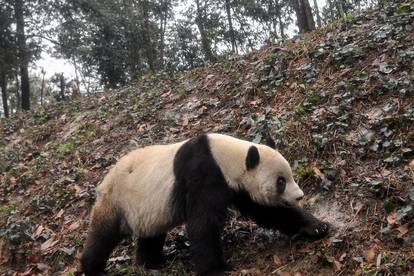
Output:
[208,134,304,205]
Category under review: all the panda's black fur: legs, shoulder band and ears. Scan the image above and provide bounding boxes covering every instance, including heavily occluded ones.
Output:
[81,135,328,275]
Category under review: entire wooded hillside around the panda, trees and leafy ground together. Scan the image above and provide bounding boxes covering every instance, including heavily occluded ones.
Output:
[0,0,414,276]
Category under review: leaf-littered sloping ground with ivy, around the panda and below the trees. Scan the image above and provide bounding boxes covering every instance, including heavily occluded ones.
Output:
[0,1,414,275]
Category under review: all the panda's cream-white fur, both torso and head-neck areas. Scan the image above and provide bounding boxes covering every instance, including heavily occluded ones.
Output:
[97,134,303,237]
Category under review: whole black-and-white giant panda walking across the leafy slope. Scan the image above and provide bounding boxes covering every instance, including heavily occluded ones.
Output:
[81,134,329,275]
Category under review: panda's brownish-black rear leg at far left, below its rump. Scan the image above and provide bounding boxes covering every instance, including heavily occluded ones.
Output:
[80,201,124,276]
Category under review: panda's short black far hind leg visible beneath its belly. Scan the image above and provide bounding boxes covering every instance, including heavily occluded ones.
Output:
[136,234,167,269]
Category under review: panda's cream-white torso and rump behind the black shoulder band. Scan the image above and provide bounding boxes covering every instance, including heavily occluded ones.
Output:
[98,141,186,237]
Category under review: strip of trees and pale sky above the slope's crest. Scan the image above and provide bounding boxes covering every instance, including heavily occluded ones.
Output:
[0,0,383,117]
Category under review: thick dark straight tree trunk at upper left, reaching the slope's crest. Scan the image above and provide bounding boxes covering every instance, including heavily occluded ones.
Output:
[14,0,30,110]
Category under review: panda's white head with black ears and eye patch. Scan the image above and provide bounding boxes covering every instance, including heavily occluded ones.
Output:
[243,137,304,205]
